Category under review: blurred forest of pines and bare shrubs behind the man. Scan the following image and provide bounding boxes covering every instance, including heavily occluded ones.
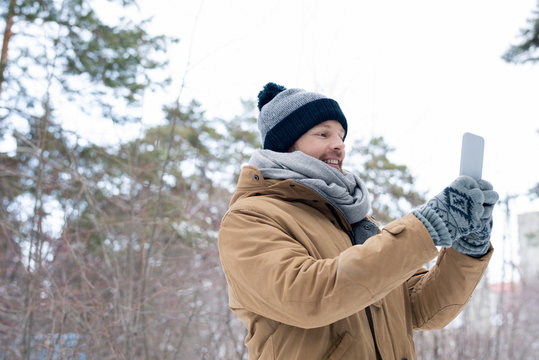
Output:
[0,0,539,359]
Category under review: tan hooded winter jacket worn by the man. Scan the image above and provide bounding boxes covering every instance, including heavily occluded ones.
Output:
[219,166,492,360]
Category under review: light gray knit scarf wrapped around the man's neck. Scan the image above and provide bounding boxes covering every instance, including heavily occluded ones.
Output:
[249,150,371,224]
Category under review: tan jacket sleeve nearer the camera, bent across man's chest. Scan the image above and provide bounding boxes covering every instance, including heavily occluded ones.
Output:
[219,200,438,328]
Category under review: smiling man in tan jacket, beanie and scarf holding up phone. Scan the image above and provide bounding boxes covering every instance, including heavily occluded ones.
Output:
[219,83,498,360]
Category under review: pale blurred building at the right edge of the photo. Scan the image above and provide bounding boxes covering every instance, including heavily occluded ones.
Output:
[518,211,539,282]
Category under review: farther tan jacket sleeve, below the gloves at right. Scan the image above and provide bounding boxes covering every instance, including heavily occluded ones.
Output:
[407,247,493,330]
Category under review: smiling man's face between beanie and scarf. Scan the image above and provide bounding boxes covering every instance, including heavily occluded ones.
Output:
[288,120,346,172]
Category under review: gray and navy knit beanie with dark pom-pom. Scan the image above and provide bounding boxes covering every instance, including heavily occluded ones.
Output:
[258,82,348,152]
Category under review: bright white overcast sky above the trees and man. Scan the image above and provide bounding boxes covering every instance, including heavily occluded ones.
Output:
[134,0,539,278]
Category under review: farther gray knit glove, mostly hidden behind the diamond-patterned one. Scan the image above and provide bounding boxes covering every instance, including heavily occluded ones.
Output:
[453,180,499,257]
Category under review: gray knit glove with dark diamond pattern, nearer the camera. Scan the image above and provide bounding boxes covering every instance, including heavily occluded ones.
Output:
[412,175,485,247]
